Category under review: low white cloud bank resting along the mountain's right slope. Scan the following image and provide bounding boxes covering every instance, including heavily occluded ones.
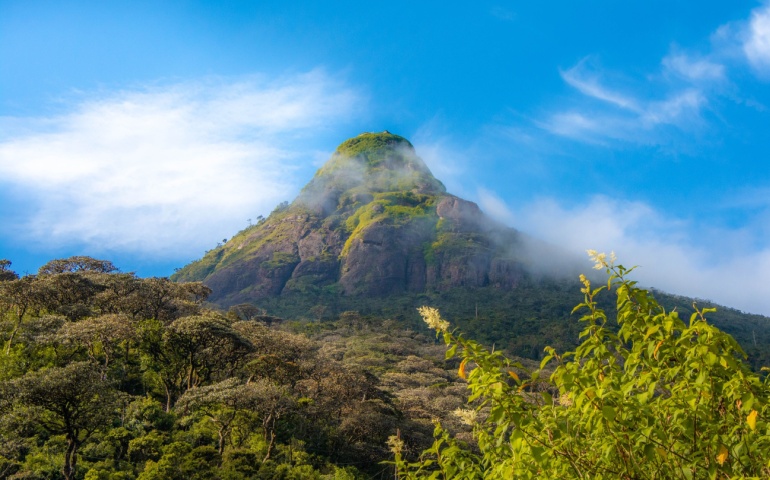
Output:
[479,192,770,315]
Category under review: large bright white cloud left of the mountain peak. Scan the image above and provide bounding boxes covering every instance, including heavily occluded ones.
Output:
[0,71,362,258]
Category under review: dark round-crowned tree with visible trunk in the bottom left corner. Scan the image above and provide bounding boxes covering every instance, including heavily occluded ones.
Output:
[0,362,118,480]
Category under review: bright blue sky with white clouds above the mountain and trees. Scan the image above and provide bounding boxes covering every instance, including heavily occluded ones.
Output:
[0,0,770,314]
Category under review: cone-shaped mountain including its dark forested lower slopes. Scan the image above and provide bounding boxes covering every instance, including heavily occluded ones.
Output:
[172,132,770,365]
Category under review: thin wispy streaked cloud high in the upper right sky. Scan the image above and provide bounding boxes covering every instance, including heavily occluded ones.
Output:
[535,2,770,144]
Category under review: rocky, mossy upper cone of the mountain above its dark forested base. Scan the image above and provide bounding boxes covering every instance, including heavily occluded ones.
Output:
[172,132,526,306]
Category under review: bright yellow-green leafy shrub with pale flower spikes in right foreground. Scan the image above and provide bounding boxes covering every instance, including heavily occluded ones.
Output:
[390,251,770,479]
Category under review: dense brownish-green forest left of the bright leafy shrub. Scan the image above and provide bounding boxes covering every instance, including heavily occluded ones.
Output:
[0,257,464,480]
